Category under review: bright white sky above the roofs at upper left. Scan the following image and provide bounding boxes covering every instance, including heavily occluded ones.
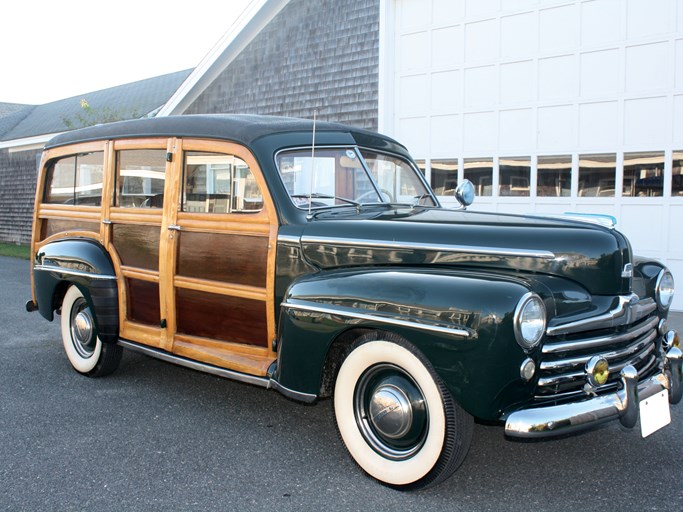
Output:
[0,0,251,105]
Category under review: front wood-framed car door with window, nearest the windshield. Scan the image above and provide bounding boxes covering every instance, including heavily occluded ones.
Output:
[159,139,277,376]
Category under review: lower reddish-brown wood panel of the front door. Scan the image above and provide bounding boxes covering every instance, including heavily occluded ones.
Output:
[176,288,269,347]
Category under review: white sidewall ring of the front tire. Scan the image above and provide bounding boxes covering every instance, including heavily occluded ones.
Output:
[334,340,446,486]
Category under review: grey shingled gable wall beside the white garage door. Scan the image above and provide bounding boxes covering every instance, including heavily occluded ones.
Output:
[184,0,379,130]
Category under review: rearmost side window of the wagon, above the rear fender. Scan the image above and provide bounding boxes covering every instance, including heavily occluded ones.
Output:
[43,151,104,206]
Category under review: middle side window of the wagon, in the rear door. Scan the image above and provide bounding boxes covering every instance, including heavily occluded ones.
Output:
[114,149,166,208]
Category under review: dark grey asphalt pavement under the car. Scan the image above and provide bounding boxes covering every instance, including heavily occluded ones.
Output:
[0,257,683,512]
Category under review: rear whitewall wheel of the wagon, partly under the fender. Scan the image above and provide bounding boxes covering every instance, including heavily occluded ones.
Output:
[61,286,123,377]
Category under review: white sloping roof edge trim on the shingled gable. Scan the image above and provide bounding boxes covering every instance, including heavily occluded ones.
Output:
[156,0,289,117]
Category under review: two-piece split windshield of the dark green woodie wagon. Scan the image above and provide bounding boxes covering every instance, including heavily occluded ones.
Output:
[277,148,436,209]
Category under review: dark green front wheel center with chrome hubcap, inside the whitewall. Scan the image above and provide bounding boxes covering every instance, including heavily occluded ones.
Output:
[354,364,429,460]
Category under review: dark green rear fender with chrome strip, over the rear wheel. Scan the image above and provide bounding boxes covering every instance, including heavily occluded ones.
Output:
[33,238,119,342]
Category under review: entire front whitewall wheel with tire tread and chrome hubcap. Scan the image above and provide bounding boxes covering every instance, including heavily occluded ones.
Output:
[334,335,474,490]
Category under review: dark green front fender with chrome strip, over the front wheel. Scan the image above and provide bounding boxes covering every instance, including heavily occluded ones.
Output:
[276,268,529,419]
